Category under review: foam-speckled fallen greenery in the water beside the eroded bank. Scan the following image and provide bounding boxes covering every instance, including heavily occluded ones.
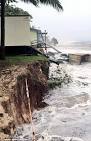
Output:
[48,64,72,88]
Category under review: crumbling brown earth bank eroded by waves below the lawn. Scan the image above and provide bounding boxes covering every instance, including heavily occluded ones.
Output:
[0,61,49,141]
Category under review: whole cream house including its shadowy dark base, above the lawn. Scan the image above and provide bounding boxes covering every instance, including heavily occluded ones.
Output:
[0,15,46,55]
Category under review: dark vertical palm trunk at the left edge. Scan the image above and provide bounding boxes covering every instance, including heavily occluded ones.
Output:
[0,0,5,59]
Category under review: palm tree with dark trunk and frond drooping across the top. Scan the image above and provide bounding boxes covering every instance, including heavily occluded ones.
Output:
[0,0,63,59]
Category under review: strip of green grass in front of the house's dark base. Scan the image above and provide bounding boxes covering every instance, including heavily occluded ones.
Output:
[5,55,48,64]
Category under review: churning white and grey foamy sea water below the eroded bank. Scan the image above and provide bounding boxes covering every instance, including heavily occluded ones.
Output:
[15,41,91,141]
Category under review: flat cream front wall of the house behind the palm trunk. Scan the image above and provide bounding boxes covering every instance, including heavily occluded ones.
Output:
[0,16,30,46]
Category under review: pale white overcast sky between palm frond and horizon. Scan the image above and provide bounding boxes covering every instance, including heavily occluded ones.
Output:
[17,0,91,41]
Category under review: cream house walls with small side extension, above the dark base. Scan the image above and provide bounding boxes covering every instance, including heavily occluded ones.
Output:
[0,15,43,46]
